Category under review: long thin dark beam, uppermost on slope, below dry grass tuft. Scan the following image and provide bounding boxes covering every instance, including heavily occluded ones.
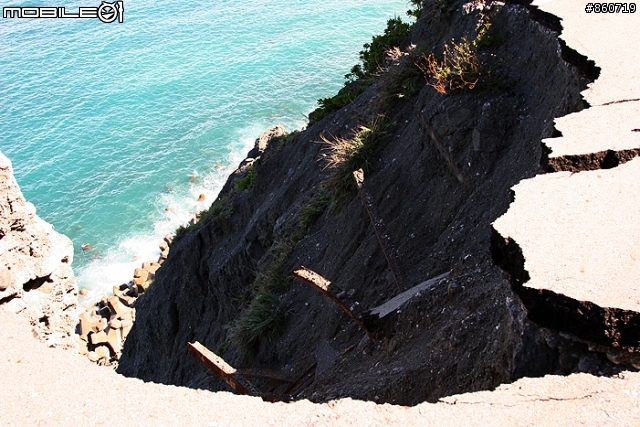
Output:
[353,169,406,292]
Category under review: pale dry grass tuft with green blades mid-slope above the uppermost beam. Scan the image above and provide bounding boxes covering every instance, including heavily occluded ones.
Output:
[320,116,386,208]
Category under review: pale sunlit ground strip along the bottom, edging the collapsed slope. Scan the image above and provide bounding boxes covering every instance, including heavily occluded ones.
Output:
[0,308,640,427]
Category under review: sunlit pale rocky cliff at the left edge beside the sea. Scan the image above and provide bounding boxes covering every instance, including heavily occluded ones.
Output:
[0,153,78,348]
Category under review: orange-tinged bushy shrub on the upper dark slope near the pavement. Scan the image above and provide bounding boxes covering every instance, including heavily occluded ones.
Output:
[416,39,486,93]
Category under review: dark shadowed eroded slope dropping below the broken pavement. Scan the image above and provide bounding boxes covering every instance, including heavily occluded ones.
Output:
[118,1,620,404]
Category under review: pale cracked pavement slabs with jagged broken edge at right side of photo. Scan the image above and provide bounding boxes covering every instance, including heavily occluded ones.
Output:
[494,0,640,350]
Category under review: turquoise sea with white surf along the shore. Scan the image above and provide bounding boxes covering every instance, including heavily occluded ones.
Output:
[0,0,408,300]
